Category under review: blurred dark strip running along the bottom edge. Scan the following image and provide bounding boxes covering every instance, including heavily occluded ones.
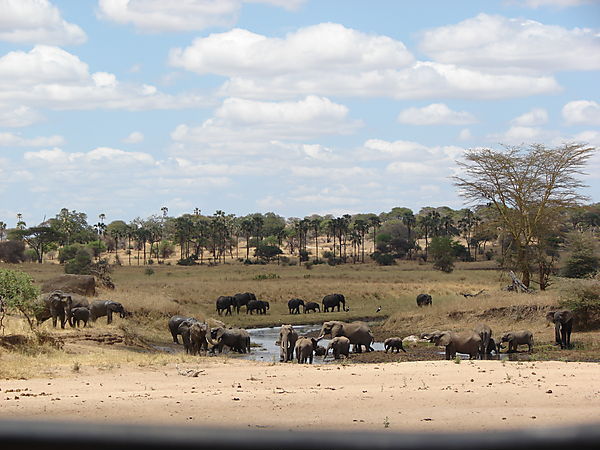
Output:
[0,420,600,450]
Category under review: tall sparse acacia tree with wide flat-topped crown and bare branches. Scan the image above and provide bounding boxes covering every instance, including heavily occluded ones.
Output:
[453,143,595,289]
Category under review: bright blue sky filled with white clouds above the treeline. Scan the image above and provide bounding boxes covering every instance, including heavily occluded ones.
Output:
[0,0,600,226]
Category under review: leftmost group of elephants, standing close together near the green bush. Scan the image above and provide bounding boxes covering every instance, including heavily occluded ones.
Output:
[35,290,129,329]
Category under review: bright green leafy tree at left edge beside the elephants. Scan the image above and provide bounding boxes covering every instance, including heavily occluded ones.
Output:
[0,269,40,330]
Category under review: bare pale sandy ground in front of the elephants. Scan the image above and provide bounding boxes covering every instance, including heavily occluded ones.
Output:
[0,357,600,431]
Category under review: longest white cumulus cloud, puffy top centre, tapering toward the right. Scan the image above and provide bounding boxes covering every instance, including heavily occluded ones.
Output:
[169,23,559,99]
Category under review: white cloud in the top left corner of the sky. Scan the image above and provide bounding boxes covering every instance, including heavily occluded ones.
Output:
[0,0,87,45]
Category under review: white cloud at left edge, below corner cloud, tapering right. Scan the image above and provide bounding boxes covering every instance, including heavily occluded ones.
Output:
[0,45,206,110]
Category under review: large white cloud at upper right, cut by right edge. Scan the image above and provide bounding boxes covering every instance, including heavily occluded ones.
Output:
[420,13,600,73]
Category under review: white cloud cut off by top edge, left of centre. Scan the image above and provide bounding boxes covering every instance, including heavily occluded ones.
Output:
[98,0,304,33]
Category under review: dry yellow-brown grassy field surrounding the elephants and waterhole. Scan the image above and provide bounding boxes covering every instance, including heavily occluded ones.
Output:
[0,262,600,377]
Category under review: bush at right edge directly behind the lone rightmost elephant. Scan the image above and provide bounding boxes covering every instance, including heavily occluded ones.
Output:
[559,282,600,330]
